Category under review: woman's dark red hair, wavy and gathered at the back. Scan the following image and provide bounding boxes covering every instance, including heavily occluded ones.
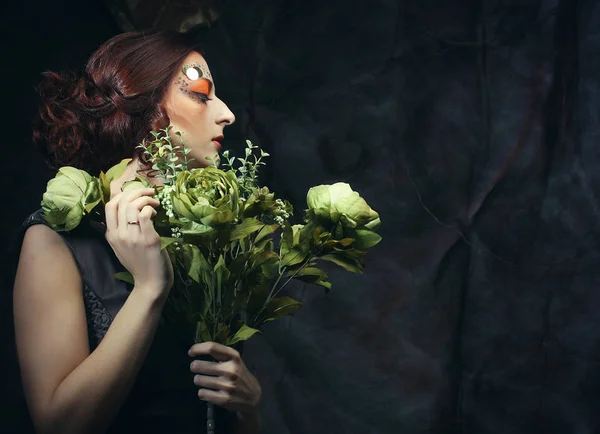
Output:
[33,32,200,175]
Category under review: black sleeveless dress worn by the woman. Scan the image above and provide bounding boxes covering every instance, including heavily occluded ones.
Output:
[21,210,235,434]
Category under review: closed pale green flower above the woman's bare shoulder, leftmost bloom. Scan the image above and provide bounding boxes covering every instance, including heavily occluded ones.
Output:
[42,166,101,231]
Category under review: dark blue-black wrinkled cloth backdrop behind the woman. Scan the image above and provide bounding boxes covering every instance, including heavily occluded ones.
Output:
[0,0,600,434]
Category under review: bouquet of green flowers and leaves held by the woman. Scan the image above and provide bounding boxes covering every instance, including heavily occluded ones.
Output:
[42,128,381,430]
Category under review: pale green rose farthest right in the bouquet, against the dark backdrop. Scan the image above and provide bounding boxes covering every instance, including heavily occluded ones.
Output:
[306,182,381,248]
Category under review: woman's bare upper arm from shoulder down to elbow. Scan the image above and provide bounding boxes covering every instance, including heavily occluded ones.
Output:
[13,224,89,420]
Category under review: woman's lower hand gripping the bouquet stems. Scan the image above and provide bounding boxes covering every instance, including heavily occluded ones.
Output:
[188,342,262,416]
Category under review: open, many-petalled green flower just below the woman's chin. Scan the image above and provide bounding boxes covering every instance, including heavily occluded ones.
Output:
[171,167,240,227]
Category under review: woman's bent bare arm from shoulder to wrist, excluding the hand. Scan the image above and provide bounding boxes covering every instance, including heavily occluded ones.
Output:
[14,225,164,434]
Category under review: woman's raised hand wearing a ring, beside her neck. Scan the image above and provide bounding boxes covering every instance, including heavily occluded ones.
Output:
[105,188,173,297]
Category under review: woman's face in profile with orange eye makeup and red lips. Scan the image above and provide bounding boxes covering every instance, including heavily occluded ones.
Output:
[163,52,235,167]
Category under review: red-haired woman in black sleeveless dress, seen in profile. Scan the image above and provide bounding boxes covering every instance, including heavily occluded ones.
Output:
[14,32,261,434]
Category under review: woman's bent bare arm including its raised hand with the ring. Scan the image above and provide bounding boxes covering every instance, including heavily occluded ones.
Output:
[13,189,173,434]
